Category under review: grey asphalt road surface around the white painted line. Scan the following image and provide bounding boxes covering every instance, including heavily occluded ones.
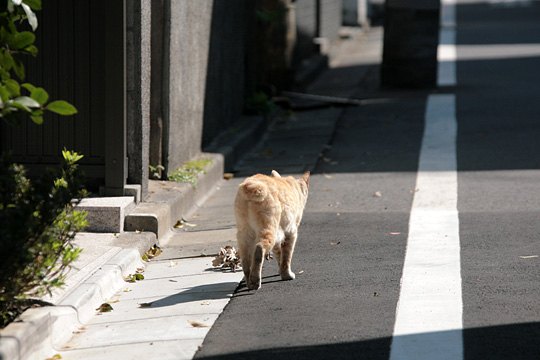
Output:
[193,1,540,360]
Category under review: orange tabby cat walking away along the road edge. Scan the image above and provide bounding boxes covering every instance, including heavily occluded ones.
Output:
[235,171,309,290]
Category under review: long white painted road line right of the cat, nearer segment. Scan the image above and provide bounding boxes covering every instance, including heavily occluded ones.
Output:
[390,95,463,360]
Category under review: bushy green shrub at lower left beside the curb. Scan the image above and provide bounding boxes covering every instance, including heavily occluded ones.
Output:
[0,150,87,327]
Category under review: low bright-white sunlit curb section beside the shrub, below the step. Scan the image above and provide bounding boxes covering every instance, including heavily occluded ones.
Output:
[0,248,144,360]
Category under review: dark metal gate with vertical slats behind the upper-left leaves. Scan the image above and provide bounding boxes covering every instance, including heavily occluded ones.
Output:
[0,0,126,194]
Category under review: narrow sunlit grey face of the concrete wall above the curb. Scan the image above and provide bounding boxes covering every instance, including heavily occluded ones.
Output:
[163,0,214,172]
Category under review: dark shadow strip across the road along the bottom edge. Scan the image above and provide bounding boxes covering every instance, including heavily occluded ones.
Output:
[195,322,540,360]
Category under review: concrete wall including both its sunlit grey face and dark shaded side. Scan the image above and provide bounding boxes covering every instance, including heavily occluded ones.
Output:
[163,0,254,162]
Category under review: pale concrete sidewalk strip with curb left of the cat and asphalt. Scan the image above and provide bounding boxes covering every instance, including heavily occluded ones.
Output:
[0,25,382,359]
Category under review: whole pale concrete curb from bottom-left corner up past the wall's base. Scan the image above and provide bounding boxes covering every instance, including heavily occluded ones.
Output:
[0,153,228,360]
